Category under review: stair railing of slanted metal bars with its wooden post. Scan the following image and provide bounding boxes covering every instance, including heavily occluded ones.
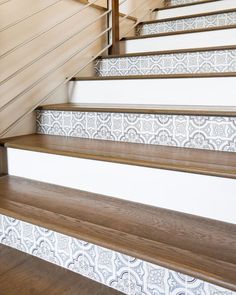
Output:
[0,0,160,137]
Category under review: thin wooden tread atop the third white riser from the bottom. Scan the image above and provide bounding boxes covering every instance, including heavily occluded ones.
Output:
[121,24,236,41]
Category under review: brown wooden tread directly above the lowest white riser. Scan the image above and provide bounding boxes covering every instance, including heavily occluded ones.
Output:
[0,134,236,179]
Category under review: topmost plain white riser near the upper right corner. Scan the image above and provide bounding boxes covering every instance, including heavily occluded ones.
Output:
[155,0,236,19]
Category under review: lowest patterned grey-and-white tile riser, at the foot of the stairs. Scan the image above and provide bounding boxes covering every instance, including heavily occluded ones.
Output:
[0,214,236,295]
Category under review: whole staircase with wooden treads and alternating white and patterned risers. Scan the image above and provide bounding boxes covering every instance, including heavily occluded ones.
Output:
[0,0,236,295]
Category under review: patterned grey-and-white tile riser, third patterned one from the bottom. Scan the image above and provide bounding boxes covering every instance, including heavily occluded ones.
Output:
[94,49,236,76]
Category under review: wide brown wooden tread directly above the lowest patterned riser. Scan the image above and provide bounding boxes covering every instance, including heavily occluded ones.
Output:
[0,176,236,290]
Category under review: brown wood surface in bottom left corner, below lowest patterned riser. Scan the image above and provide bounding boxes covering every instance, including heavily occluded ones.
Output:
[0,244,123,295]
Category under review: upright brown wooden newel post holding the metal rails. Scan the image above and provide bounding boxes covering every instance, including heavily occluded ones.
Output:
[108,0,120,54]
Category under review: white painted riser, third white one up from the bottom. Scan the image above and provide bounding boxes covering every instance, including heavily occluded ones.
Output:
[121,29,236,53]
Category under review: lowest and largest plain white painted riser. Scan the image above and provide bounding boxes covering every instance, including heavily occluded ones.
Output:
[8,149,236,223]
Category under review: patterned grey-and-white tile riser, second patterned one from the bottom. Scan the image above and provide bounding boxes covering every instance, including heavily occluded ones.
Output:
[36,111,236,152]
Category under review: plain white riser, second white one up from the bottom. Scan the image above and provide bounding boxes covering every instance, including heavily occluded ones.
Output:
[69,77,236,106]
